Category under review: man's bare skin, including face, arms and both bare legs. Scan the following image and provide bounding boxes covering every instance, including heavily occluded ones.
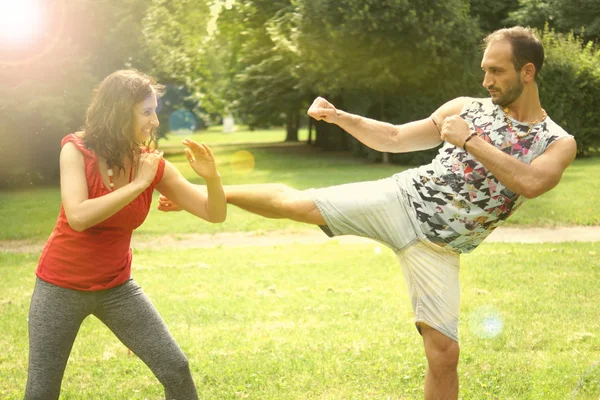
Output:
[158,36,577,400]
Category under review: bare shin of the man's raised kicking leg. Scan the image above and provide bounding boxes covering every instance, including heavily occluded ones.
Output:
[225,183,325,225]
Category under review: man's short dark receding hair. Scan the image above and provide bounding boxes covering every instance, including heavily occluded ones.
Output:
[483,26,544,78]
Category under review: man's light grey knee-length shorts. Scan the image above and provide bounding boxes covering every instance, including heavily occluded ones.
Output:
[308,177,460,342]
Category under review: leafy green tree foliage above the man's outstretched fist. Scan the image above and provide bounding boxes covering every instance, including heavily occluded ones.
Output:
[146,0,486,148]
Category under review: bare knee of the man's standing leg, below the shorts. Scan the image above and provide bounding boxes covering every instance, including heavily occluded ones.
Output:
[420,323,460,371]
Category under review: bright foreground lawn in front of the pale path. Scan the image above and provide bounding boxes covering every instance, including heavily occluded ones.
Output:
[0,241,600,400]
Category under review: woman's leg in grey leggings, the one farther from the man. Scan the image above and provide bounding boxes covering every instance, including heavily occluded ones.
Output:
[25,278,94,400]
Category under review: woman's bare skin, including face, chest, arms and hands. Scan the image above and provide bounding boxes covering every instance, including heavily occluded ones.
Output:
[60,93,227,232]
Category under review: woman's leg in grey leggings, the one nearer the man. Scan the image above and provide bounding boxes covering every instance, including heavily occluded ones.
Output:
[94,279,198,400]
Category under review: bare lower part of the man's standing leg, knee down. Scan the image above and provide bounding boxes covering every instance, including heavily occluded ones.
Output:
[419,323,460,400]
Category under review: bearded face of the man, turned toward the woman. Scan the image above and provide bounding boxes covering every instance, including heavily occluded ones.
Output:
[481,40,525,107]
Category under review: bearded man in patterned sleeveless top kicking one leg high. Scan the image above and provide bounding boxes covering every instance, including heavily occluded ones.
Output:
[159,27,576,399]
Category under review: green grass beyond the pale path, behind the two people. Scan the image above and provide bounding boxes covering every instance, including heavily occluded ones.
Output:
[0,143,600,240]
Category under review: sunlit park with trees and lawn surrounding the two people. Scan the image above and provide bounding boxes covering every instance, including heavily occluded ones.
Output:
[0,0,600,399]
